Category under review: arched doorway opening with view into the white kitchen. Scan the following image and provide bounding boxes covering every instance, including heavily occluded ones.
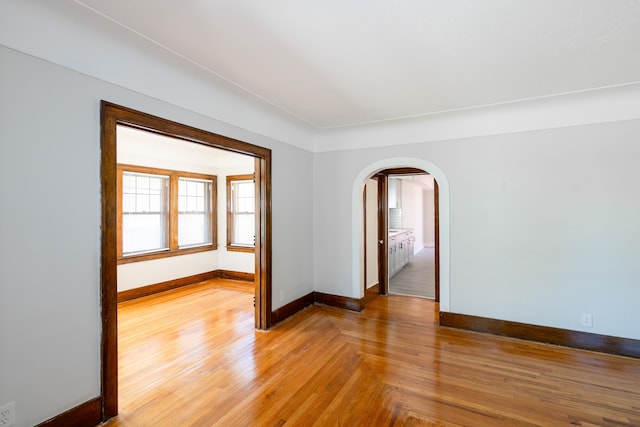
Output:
[363,168,440,302]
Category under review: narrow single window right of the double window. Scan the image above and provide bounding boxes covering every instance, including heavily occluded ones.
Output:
[227,174,255,252]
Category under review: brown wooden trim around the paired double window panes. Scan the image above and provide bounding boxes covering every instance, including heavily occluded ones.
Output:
[117,163,218,264]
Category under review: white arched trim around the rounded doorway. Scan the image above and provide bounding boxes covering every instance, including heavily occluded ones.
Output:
[351,157,451,311]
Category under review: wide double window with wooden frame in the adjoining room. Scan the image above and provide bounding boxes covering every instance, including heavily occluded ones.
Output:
[118,165,216,263]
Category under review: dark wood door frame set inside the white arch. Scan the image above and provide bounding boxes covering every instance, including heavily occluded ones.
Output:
[375,167,440,302]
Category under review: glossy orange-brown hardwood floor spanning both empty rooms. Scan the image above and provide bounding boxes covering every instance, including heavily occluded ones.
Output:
[101,281,640,427]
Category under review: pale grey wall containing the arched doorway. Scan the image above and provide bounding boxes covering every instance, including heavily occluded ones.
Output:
[314,120,640,339]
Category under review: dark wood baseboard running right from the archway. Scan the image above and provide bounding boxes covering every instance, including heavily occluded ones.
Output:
[440,312,640,358]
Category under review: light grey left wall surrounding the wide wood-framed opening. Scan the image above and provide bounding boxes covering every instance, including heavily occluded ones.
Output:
[0,46,313,427]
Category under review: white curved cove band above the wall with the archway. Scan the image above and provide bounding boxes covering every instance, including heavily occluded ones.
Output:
[314,82,640,153]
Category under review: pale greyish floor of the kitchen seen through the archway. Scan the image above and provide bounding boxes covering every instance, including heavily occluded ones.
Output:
[389,248,436,299]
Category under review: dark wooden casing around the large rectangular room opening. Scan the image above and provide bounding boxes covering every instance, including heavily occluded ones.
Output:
[100,101,272,421]
